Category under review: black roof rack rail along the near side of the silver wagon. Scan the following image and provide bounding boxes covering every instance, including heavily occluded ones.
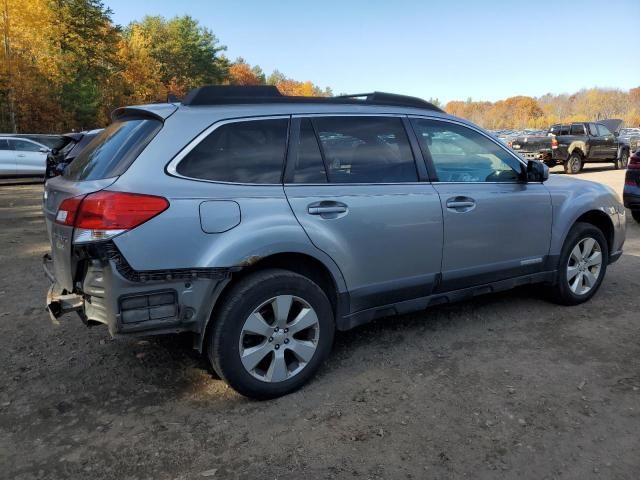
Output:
[182,85,442,112]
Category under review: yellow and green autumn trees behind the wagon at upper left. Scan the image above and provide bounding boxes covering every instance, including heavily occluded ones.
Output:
[0,0,332,132]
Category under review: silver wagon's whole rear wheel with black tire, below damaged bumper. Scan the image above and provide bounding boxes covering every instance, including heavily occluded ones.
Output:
[207,269,335,400]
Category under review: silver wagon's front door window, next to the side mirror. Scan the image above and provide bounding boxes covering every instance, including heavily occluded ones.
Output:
[411,118,522,182]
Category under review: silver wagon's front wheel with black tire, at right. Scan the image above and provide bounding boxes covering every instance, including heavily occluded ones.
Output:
[552,222,609,305]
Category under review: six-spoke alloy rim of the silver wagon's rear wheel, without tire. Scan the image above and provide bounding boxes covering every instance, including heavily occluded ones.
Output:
[239,295,320,383]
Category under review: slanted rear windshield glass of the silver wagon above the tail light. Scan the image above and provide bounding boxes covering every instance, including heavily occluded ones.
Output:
[64,118,162,180]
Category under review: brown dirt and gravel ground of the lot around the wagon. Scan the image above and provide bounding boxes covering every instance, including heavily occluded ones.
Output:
[0,169,640,479]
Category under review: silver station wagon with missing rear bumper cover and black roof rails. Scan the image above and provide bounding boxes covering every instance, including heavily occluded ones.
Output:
[44,86,625,399]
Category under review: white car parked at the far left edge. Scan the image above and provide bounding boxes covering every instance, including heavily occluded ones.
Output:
[0,137,50,177]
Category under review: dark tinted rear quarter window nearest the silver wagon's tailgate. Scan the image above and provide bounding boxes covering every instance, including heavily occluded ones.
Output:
[176,118,289,184]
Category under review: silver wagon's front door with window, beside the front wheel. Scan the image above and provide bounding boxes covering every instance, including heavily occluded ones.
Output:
[411,118,552,291]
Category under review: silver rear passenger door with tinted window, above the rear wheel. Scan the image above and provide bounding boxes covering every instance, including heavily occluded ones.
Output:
[284,115,442,312]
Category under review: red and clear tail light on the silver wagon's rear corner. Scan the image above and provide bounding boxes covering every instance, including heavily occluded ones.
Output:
[56,190,169,243]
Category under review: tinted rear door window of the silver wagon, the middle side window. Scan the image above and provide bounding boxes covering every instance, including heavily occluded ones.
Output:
[308,116,418,183]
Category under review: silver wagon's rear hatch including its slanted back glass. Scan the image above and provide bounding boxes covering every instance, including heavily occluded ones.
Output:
[43,111,162,292]
